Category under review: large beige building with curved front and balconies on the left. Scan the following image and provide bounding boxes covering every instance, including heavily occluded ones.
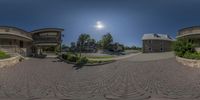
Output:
[0,26,64,56]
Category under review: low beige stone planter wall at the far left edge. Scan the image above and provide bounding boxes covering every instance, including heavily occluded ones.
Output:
[0,56,21,68]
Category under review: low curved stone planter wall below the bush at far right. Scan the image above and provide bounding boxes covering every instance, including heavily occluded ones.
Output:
[176,56,200,68]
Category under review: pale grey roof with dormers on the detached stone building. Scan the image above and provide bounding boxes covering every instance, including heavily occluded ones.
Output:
[142,33,174,41]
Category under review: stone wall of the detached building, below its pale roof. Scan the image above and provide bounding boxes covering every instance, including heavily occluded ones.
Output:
[143,40,172,53]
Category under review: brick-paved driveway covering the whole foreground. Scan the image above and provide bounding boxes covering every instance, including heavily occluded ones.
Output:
[0,54,200,100]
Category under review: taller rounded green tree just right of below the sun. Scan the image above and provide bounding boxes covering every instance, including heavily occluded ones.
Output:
[100,33,113,49]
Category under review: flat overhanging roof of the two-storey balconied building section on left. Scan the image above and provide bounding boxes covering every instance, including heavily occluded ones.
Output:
[31,28,64,33]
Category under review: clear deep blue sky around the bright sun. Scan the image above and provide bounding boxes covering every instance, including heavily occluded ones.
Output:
[0,0,200,47]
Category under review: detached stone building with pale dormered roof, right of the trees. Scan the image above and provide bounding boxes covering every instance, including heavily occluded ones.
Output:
[142,34,174,53]
